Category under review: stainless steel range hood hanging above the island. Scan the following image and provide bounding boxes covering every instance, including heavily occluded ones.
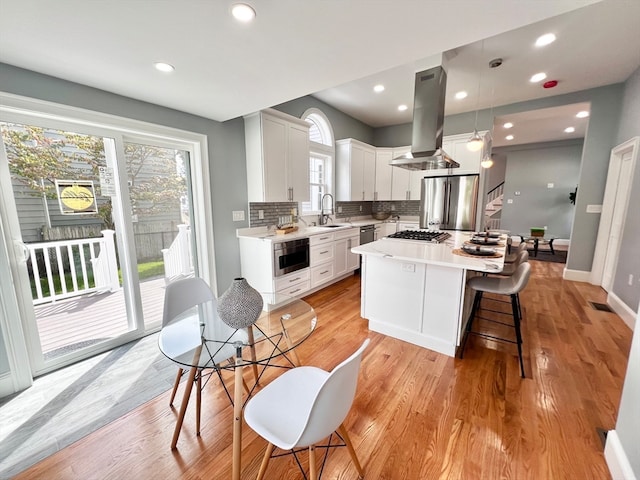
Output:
[390,66,460,170]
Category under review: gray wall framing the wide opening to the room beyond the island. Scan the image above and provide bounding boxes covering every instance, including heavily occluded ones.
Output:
[374,84,624,276]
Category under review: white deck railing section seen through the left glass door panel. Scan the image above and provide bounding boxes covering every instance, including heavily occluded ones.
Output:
[26,230,120,305]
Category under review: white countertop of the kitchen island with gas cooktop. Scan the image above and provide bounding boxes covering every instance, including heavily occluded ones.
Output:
[351,231,506,273]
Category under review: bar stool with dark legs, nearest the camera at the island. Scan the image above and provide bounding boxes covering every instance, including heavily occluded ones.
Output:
[460,262,531,378]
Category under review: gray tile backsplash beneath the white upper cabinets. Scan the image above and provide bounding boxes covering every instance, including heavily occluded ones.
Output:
[249,200,420,227]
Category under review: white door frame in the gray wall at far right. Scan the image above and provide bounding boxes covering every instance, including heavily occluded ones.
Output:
[590,137,640,290]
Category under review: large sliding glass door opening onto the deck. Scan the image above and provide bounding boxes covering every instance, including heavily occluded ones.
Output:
[0,109,198,375]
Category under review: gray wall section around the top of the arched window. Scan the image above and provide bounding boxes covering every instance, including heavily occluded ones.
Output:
[273,95,373,145]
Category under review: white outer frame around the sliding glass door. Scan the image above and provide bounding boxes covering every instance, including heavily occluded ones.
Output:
[0,92,217,389]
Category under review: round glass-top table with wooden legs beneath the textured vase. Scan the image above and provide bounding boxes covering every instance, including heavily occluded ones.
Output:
[158,293,317,480]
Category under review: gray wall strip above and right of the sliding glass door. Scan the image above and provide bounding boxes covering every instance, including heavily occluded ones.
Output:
[0,63,248,293]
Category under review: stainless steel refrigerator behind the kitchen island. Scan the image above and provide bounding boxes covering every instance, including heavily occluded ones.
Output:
[420,175,480,230]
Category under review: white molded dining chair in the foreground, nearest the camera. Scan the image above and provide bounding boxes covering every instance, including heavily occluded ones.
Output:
[244,339,369,480]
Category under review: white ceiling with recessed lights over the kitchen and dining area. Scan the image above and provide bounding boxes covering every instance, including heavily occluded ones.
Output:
[0,0,640,147]
